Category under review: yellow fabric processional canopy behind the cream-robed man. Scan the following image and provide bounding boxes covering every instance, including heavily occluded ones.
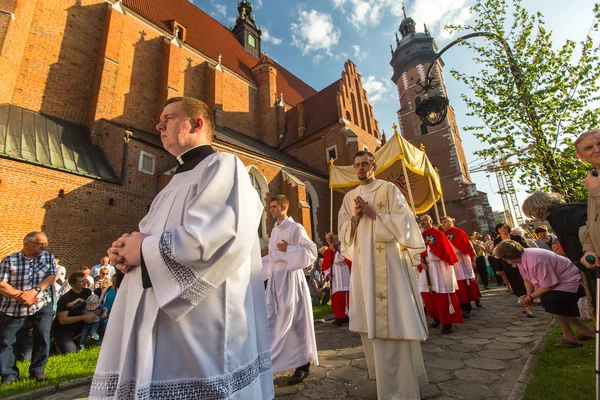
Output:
[329,133,442,214]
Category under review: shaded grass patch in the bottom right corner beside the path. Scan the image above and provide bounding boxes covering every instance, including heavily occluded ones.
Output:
[524,326,596,400]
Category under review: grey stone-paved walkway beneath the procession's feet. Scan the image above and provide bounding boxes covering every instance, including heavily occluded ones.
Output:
[44,288,551,400]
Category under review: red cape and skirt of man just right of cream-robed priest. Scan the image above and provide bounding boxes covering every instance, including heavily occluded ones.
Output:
[418,227,463,325]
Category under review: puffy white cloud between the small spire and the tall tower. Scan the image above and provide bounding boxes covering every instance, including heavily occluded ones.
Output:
[291,10,340,56]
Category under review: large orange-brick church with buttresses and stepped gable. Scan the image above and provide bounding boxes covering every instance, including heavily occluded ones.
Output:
[0,0,382,268]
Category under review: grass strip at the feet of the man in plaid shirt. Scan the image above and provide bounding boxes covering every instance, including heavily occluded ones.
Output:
[0,347,100,398]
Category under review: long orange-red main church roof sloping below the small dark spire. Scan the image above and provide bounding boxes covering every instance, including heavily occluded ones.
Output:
[123,0,317,106]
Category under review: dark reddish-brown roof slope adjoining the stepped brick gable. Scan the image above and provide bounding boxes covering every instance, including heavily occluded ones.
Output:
[280,79,341,148]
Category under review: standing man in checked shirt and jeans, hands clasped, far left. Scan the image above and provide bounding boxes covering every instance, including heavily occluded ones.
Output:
[0,232,56,385]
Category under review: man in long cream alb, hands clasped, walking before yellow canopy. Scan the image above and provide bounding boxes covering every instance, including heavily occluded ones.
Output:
[338,151,427,400]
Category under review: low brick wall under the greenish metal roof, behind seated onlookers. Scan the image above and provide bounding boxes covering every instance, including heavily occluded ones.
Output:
[0,158,152,270]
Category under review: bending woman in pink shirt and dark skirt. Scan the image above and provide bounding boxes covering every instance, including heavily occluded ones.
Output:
[494,240,594,349]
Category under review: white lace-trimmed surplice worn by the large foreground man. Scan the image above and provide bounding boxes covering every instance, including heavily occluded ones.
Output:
[89,153,274,400]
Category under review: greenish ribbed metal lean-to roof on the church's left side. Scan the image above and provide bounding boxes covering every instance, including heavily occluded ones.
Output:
[0,104,120,183]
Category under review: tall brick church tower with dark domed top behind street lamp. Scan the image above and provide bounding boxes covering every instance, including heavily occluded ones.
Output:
[390,8,493,233]
